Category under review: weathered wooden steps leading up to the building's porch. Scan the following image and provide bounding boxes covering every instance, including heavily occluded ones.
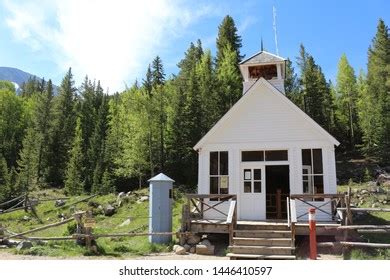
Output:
[227,222,295,260]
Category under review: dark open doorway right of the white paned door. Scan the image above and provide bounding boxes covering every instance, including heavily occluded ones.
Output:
[265,165,290,219]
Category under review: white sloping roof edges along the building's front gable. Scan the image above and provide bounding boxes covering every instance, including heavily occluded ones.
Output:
[194,78,340,150]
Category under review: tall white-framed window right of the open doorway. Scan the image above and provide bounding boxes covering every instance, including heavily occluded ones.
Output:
[302,149,324,197]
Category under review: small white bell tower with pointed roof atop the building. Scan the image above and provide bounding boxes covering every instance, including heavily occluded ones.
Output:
[240,50,286,94]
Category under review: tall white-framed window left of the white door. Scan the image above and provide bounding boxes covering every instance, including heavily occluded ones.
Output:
[210,151,229,194]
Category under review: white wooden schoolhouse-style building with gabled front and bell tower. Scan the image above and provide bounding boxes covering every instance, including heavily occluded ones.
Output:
[194,51,339,221]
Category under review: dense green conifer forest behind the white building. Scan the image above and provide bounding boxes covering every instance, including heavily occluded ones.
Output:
[0,16,390,201]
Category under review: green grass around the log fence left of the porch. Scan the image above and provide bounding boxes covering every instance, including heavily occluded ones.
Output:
[0,188,184,258]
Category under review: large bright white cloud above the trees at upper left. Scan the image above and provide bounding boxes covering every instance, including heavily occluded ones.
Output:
[5,0,213,92]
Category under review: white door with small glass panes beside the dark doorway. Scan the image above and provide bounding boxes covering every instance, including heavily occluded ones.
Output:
[238,163,266,220]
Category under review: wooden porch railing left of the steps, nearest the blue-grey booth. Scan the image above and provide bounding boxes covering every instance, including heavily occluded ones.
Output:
[182,194,237,245]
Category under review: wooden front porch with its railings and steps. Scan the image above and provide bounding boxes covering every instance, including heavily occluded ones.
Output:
[181,194,345,259]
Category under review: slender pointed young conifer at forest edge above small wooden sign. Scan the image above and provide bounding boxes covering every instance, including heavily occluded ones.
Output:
[65,118,84,195]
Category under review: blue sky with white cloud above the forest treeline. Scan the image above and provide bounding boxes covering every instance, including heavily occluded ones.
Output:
[0,0,390,92]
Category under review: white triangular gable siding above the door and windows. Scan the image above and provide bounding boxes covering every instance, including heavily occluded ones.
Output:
[207,83,326,143]
